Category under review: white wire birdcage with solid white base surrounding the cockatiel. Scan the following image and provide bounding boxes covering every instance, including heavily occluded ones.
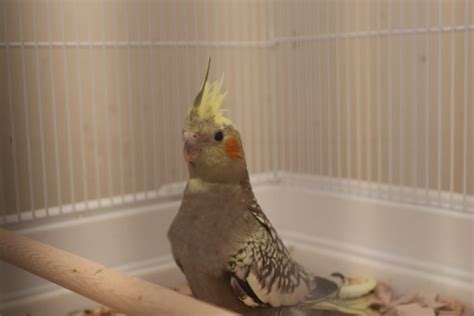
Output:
[0,0,474,315]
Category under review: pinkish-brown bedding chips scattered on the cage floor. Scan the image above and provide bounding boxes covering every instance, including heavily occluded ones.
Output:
[70,283,474,316]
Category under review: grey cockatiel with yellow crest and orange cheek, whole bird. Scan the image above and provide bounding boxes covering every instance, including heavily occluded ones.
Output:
[168,61,376,315]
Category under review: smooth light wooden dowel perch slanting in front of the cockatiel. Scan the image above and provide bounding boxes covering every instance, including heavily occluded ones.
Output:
[0,229,235,316]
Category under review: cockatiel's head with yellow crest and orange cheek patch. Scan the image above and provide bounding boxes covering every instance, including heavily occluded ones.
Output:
[183,60,248,183]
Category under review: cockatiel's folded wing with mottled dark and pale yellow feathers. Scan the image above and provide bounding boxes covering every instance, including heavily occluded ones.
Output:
[228,202,337,307]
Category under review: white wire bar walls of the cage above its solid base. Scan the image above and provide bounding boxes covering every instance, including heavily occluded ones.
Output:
[0,0,474,224]
